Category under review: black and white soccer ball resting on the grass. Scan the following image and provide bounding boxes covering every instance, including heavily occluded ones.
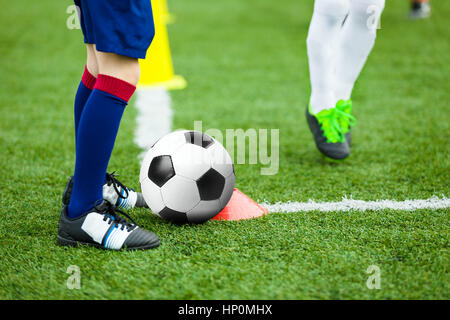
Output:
[139,130,235,224]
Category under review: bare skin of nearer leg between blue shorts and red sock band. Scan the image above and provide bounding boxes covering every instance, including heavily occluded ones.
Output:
[96,51,140,86]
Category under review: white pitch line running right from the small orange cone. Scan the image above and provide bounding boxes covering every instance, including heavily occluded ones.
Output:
[261,197,450,213]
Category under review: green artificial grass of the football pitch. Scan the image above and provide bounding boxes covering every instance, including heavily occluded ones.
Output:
[0,0,450,299]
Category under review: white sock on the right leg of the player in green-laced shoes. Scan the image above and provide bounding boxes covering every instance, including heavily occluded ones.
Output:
[334,0,385,100]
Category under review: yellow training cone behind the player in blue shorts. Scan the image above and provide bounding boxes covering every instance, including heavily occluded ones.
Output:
[138,0,187,90]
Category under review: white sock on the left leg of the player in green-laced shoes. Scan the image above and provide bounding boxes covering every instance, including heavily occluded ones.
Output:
[306,0,350,114]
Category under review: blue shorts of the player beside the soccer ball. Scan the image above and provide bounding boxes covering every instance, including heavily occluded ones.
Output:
[75,0,155,59]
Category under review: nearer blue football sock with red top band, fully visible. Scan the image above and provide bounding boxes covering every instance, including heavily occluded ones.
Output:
[68,74,135,218]
